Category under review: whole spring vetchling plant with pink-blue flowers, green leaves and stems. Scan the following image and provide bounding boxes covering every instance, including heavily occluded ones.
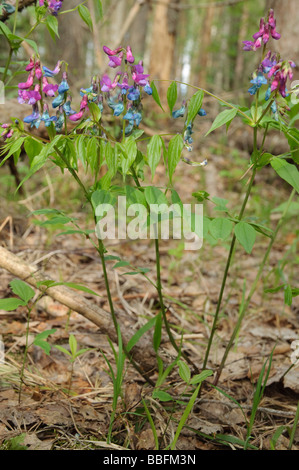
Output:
[2,8,299,448]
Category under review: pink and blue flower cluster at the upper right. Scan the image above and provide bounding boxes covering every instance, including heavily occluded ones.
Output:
[243,9,296,119]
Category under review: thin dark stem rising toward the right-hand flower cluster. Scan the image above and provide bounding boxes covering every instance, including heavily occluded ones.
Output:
[202,162,256,369]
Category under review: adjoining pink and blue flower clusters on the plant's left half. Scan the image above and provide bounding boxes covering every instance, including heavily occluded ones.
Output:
[2,46,152,138]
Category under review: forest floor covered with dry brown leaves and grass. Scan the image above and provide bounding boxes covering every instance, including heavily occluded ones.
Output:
[0,113,299,450]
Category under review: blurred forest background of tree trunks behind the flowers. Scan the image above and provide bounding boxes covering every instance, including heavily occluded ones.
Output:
[0,0,299,109]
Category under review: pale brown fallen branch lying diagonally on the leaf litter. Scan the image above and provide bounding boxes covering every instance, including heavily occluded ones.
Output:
[0,247,156,373]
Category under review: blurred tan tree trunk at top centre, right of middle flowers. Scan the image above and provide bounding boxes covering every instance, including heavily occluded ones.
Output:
[149,0,179,104]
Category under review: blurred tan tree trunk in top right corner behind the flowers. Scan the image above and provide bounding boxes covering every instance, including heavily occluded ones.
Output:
[266,0,299,79]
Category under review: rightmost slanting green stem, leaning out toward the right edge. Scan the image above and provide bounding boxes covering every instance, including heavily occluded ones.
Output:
[214,189,296,386]
